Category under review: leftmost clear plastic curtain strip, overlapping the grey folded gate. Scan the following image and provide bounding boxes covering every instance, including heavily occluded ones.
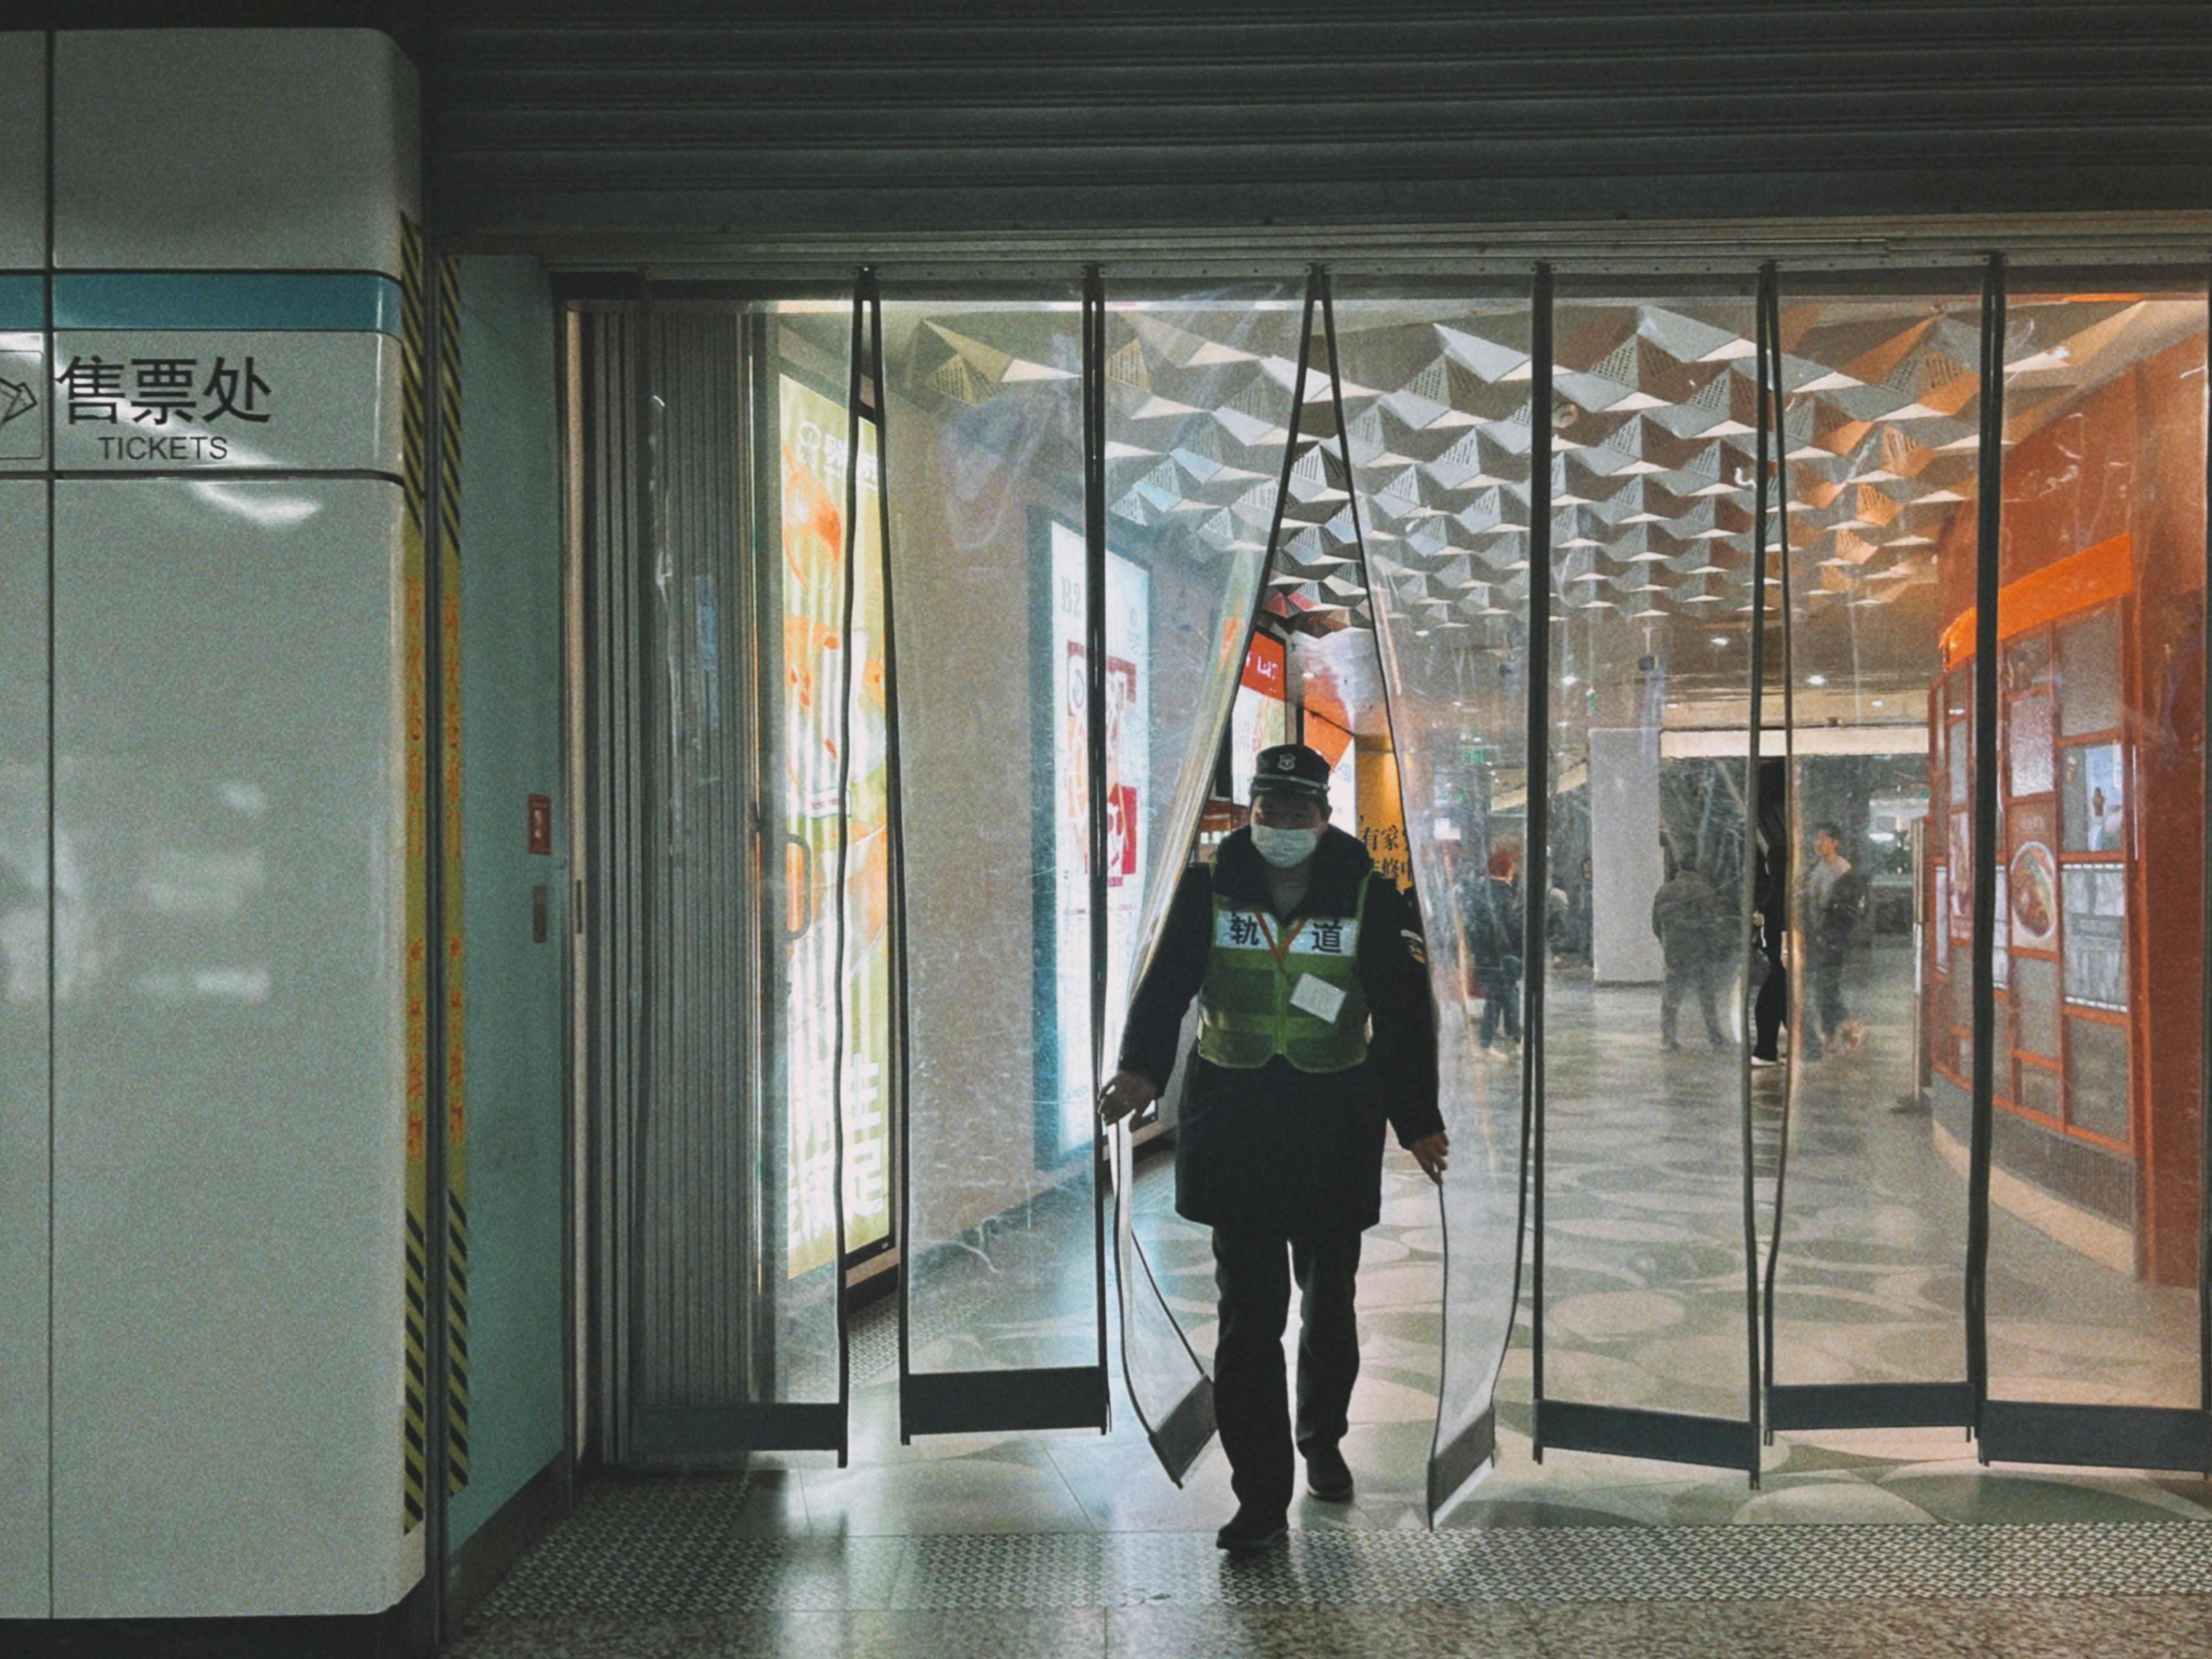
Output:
[630,305,874,1460]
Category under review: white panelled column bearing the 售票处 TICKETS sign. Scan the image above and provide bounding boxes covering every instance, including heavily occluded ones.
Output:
[47,29,425,1619]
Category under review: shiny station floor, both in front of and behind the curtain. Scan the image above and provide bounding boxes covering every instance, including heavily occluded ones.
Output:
[460,962,2212,1659]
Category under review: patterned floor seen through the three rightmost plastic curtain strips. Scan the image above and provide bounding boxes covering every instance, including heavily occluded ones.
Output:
[1540,945,2201,1456]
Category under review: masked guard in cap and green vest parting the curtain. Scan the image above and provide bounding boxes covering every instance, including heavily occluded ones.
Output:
[1099,743,1449,1551]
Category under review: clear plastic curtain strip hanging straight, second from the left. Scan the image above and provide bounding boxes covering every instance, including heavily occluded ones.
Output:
[882,285,1110,1435]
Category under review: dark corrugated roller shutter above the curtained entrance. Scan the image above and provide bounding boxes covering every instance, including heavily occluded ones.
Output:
[431,0,2212,252]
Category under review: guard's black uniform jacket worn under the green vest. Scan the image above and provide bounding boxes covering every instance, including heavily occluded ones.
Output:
[1119,830,1444,1237]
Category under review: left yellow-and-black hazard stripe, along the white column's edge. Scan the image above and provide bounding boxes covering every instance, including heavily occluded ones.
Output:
[400,219,429,1533]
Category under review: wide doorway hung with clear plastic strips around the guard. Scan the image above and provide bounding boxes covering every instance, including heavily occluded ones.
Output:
[571,266,2212,1515]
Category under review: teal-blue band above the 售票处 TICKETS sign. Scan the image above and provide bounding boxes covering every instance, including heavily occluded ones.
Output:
[53,270,400,334]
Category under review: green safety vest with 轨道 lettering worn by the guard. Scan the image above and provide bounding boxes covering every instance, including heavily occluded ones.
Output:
[1199,881,1367,1071]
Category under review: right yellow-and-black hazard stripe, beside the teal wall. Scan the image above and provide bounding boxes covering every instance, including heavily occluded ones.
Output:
[438,254,469,1493]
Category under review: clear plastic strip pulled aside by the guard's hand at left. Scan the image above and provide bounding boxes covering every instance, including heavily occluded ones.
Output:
[1095,283,1301,1482]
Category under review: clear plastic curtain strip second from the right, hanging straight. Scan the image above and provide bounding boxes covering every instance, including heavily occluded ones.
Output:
[1752,274,1991,1429]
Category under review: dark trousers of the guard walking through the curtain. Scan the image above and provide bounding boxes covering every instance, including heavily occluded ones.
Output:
[1214,1228,1360,1515]
